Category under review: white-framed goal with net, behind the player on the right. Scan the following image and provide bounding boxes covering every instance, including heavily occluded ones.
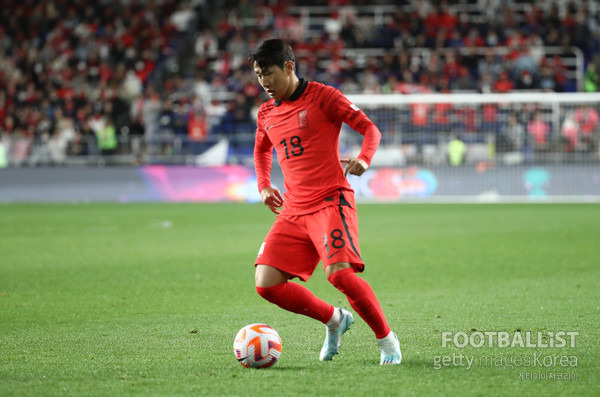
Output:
[340,92,600,201]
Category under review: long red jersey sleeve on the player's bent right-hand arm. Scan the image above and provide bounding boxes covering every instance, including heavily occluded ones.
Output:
[321,86,381,165]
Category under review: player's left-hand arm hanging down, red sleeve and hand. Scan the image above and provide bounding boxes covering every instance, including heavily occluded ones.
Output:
[254,121,283,214]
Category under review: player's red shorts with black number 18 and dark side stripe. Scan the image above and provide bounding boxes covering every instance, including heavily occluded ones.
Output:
[255,192,365,281]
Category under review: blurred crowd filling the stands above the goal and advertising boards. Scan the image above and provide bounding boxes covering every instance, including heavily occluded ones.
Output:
[0,0,600,166]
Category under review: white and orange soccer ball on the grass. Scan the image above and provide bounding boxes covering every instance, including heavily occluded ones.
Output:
[233,323,281,368]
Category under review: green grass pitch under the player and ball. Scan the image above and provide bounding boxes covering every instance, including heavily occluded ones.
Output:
[0,204,600,396]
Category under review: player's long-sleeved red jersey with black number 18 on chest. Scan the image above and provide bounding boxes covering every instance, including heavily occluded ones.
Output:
[254,80,381,215]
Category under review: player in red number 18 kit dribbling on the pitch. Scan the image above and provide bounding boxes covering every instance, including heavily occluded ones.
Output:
[248,39,402,365]
